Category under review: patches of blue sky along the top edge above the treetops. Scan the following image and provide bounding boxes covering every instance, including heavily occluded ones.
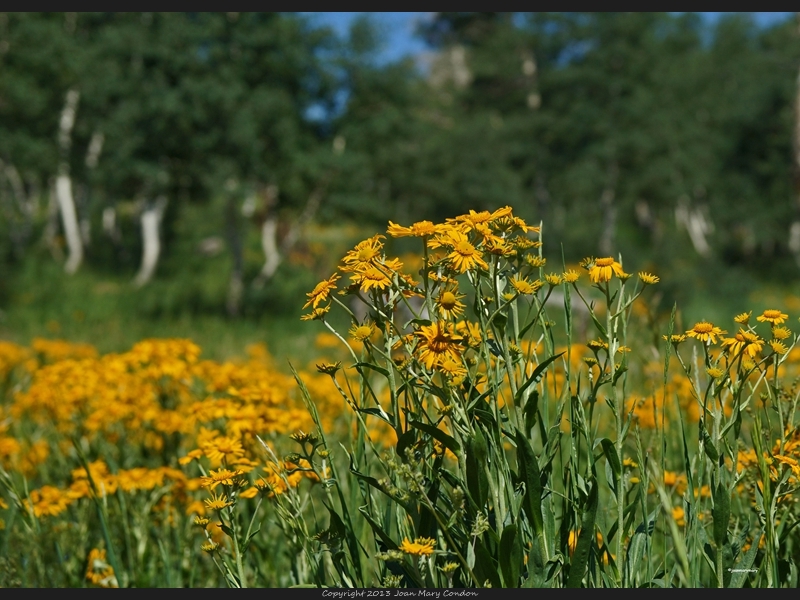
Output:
[305,12,792,62]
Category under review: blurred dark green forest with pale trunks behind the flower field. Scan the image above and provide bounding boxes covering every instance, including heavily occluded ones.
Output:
[0,13,800,358]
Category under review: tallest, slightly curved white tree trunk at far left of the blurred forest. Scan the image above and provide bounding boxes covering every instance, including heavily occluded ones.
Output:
[56,89,83,273]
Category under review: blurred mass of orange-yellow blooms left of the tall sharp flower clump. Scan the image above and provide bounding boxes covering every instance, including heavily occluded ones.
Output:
[0,339,336,528]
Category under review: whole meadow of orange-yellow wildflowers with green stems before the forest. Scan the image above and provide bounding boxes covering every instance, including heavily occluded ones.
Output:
[0,208,800,588]
